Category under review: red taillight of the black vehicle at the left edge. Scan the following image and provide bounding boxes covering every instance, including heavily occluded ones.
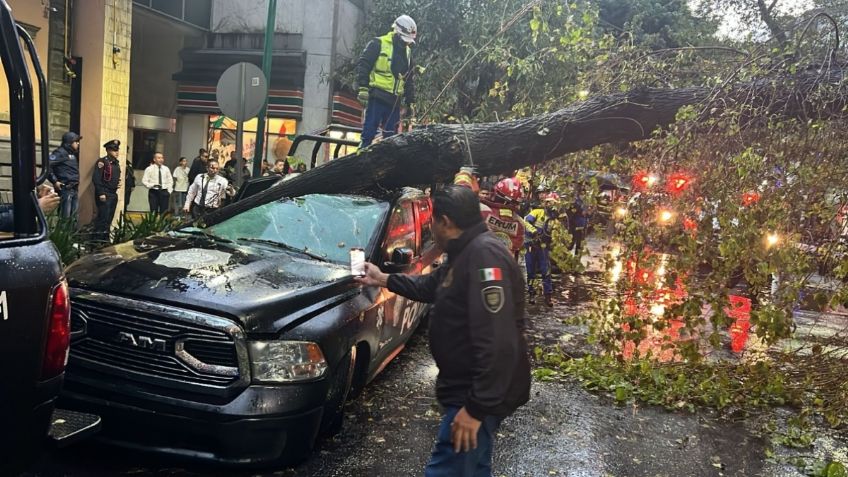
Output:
[41,280,71,379]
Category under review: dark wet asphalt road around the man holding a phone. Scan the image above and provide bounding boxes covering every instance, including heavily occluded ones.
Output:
[19,290,801,477]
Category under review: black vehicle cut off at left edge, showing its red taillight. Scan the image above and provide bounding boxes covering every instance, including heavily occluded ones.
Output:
[0,0,98,475]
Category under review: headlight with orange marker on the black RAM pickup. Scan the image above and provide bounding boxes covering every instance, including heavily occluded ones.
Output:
[248,341,327,383]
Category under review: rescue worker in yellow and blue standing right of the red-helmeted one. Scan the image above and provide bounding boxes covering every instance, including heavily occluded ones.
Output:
[524,192,559,307]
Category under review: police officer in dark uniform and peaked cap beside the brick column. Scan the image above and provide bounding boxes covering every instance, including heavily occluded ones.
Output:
[92,139,121,241]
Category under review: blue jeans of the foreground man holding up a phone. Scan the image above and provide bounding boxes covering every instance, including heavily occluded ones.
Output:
[424,407,501,477]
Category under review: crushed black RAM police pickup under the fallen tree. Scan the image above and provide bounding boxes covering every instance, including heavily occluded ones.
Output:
[63,190,437,465]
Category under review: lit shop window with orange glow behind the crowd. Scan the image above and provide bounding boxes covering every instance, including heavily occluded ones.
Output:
[207,114,297,166]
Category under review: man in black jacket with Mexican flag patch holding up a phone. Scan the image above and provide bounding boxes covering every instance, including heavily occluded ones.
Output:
[358,185,530,477]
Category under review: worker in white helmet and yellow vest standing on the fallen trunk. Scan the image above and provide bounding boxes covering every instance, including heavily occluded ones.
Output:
[356,15,418,148]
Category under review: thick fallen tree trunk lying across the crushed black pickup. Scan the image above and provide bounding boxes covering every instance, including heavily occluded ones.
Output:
[206,64,848,224]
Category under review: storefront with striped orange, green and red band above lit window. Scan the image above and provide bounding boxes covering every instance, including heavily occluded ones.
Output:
[177,84,303,166]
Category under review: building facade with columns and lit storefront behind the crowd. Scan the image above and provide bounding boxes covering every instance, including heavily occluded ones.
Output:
[0,0,365,219]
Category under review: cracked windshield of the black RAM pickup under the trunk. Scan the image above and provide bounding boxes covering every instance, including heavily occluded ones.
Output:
[206,194,389,263]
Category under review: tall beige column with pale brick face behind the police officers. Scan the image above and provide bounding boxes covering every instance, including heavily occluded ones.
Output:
[73,0,132,224]
